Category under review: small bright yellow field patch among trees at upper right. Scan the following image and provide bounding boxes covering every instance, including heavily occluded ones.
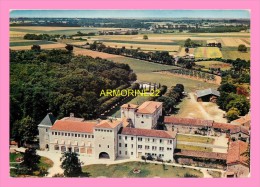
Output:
[194,47,222,58]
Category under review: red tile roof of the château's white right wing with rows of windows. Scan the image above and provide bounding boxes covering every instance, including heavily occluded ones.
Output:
[120,127,176,139]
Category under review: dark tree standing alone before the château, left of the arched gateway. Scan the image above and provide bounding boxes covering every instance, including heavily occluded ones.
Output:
[61,151,82,177]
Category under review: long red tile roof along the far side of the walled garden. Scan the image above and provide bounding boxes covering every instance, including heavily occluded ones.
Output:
[164,116,213,127]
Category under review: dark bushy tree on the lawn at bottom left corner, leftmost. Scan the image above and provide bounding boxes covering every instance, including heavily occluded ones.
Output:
[22,148,41,171]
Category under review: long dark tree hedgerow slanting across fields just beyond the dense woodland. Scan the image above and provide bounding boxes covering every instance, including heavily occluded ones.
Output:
[84,41,175,65]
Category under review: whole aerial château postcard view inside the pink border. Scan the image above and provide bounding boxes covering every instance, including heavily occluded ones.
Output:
[9,10,251,178]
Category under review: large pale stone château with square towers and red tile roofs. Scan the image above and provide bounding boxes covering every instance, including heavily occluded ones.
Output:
[38,101,176,160]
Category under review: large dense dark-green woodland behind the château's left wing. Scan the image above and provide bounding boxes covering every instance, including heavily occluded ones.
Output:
[10,50,136,142]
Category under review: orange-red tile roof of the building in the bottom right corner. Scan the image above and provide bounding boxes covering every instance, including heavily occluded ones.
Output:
[227,140,248,165]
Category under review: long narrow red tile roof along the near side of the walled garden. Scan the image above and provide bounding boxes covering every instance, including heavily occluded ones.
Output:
[175,150,227,160]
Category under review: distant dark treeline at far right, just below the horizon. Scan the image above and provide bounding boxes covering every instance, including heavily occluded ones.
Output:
[189,26,249,33]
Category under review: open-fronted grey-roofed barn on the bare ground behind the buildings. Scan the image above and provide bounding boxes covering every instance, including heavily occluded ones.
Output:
[195,88,220,103]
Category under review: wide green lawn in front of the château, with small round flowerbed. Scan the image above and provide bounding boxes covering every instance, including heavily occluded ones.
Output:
[82,162,203,178]
